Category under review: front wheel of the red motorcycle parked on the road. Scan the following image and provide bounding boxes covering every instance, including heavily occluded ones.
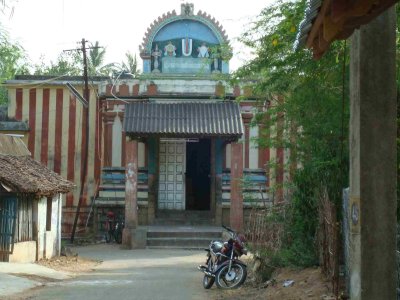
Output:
[215,263,247,289]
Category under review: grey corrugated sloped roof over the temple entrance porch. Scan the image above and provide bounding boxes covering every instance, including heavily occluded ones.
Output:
[124,101,243,139]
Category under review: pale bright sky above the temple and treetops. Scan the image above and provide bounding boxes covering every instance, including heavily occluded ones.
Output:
[0,0,273,70]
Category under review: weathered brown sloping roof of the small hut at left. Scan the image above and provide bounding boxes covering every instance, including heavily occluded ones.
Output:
[0,154,74,197]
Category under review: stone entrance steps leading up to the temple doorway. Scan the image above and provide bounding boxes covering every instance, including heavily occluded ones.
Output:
[147,211,222,249]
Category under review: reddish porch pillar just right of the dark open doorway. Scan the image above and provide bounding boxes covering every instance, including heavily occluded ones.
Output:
[230,142,243,231]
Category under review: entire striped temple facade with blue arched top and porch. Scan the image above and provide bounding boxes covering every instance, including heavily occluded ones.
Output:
[6,4,285,234]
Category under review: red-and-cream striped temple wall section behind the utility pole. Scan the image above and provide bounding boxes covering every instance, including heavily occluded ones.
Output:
[8,84,101,232]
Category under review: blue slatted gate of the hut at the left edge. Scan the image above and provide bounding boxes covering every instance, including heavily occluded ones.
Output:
[0,196,17,261]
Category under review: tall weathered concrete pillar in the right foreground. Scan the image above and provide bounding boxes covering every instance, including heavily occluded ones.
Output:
[348,6,397,300]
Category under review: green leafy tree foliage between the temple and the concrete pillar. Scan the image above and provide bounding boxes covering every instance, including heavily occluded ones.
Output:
[234,0,349,266]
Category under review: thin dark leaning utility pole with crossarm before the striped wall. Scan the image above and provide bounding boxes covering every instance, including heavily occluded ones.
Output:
[64,39,101,243]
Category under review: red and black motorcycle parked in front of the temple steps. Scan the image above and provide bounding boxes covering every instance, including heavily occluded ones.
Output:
[198,226,247,289]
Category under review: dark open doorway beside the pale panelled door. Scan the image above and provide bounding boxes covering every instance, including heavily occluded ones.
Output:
[186,139,211,210]
